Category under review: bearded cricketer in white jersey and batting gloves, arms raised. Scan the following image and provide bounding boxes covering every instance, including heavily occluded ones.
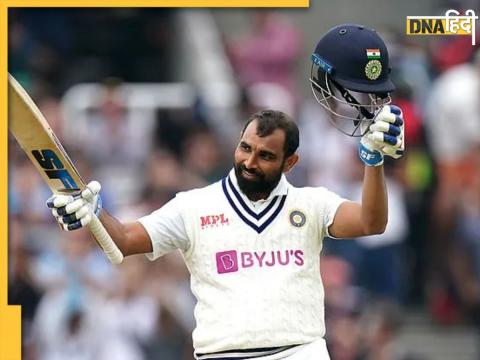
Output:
[48,24,403,360]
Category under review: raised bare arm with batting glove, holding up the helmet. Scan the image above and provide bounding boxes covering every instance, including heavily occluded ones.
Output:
[328,105,404,238]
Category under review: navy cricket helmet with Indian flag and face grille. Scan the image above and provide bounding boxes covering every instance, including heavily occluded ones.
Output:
[310,24,395,136]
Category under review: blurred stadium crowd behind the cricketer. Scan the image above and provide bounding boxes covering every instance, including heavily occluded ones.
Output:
[8,0,480,360]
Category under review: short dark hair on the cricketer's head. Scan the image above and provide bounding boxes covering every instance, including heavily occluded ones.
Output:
[242,110,300,158]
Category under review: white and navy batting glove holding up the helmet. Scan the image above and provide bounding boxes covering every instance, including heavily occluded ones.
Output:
[358,105,405,166]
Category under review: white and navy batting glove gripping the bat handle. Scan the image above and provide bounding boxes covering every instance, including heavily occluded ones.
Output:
[47,181,102,231]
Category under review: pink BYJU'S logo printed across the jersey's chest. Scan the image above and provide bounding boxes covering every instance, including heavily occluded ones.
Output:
[215,249,305,274]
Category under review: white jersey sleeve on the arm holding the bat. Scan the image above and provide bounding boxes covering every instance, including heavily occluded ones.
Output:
[138,195,190,260]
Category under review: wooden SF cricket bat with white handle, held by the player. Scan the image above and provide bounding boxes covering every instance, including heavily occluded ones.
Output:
[8,74,123,264]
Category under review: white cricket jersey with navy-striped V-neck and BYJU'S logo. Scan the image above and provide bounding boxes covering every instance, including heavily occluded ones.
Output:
[139,170,344,354]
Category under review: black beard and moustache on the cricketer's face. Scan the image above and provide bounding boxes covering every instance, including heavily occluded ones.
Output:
[234,164,283,201]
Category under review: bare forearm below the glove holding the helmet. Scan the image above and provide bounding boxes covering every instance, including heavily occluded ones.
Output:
[361,166,388,235]
